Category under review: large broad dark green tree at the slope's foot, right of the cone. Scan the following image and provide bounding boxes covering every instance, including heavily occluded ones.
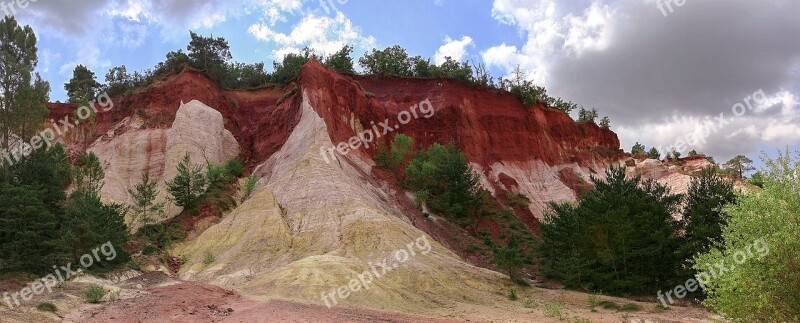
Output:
[540,167,684,295]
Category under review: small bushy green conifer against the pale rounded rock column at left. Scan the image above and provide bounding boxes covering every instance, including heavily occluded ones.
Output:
[167,153,208,212]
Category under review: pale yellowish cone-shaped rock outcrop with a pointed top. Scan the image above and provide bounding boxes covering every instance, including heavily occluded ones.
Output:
[174,93,503,311]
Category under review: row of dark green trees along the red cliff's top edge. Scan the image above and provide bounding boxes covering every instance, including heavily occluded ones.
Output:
[65,32,610,125]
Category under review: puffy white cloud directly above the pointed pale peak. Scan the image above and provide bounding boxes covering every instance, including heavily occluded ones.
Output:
[247,12,376,58]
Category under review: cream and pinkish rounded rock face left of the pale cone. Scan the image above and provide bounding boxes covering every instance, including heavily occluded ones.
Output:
[88,100,240,228]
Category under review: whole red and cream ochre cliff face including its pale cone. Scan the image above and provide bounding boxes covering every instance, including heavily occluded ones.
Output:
[45,61,680,312]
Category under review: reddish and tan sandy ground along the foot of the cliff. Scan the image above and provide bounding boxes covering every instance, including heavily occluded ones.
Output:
[0,272,710,323]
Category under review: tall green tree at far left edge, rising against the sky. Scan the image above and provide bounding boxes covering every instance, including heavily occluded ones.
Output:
[0,15,46,180]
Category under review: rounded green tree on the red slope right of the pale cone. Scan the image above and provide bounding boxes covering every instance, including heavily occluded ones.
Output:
[405,143,480,219]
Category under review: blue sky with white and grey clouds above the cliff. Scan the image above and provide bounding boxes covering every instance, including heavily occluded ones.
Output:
[7,0,800,165]
